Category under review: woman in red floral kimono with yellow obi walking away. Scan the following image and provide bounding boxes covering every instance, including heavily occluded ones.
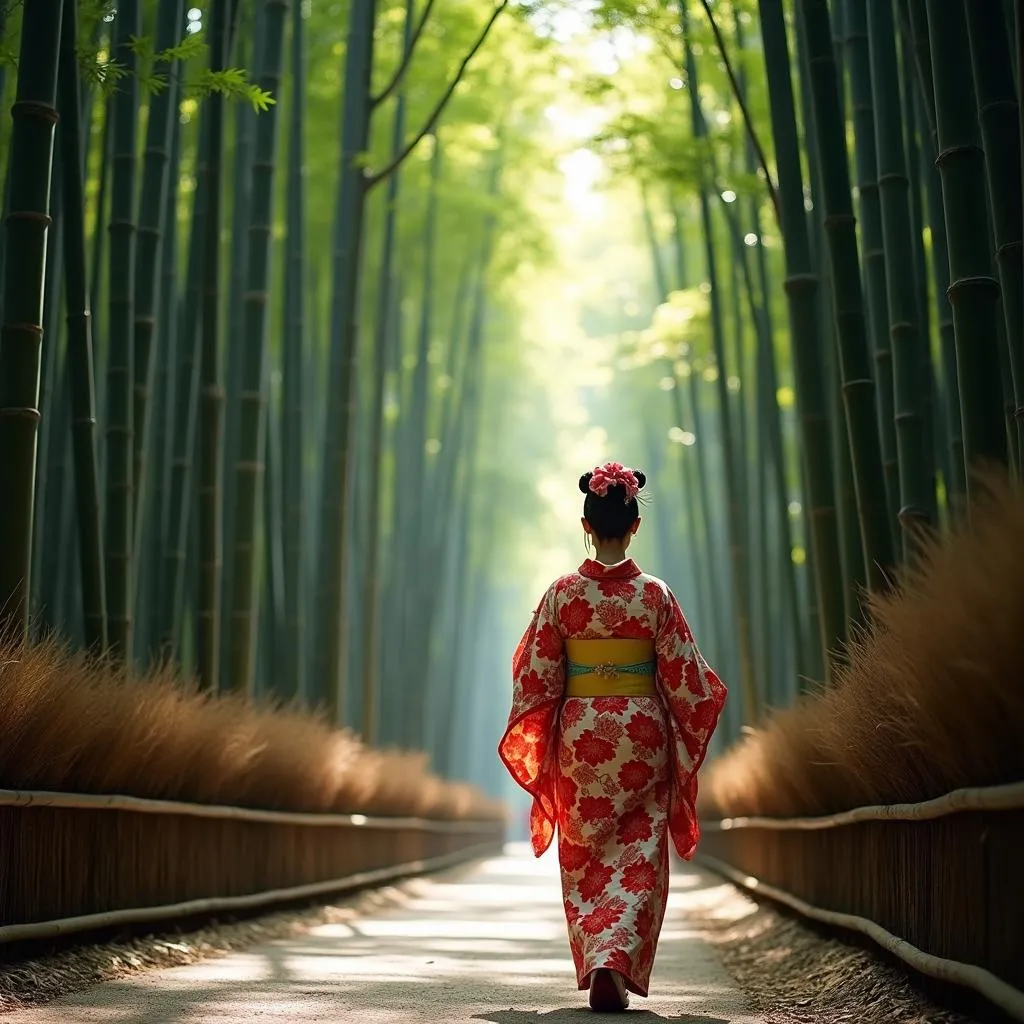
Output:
[499,463,726,1011]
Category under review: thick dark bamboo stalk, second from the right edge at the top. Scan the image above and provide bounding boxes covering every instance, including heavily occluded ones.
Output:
[927,0,1008,481]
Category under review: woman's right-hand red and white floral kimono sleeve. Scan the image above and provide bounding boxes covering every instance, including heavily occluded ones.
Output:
[654,587,726,860]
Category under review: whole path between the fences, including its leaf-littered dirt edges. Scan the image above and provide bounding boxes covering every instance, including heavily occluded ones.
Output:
[0,847,976,1024]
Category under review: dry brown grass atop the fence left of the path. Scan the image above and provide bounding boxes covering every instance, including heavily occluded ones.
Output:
[0,641,505,820]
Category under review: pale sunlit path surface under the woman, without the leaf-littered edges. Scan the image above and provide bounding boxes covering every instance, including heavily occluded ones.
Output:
[13,846,762,1024]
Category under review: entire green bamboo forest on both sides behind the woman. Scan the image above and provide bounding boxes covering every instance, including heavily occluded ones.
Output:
[0,0,1024,786]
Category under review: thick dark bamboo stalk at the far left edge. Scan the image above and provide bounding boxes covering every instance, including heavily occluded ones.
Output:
[0,0,62,642]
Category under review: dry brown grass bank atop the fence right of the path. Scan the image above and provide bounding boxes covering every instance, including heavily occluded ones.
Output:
[700,475,1024,817]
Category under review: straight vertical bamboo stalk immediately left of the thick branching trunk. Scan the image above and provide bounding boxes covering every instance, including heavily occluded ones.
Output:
[279,2,308,696]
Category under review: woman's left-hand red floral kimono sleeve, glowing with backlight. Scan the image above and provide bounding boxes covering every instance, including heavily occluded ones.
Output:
[498,587,565,857]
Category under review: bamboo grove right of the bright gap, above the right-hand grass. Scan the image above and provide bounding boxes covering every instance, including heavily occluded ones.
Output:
[577,0,1024,736]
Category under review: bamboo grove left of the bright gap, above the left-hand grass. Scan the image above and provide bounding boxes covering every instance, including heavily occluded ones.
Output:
[0,0,561,790]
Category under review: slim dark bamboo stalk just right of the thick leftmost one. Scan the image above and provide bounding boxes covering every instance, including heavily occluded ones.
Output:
[59,3,106,652]
